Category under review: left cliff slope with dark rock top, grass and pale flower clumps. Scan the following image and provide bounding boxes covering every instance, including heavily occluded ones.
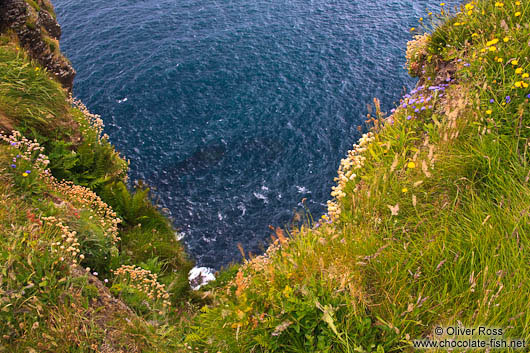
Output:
[0,0,192,352]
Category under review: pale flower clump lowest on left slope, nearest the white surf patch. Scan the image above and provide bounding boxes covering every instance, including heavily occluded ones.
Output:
[111,265,171,315]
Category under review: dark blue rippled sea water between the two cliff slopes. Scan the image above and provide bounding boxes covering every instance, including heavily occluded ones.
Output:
[54,0,458,268]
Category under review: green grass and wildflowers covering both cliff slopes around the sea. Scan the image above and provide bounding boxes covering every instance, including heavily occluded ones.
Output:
[0,0,530,353]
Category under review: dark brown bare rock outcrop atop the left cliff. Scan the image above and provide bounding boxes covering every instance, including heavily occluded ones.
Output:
[0,0,76,91]
